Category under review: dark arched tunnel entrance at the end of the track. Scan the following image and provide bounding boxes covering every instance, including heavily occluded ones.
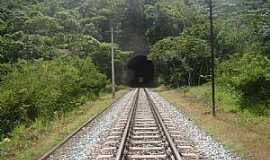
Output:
[126,55,154,87]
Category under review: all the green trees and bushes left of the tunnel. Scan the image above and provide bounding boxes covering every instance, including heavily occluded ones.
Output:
[0,0,128,139]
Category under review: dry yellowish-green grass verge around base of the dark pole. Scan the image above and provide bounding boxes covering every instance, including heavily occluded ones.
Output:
[157,85,270,160]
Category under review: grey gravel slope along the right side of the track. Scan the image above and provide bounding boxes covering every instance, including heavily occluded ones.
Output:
[149,90,241,160]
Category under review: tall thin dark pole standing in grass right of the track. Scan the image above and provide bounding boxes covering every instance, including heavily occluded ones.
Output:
[209,0,216,117]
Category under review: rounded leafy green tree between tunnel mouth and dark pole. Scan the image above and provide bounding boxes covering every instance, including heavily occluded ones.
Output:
[148,34,209,87]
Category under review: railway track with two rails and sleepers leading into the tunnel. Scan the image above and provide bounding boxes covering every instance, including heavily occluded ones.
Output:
[96,89,202,160]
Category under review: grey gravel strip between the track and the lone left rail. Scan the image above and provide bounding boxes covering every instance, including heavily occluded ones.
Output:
[49,91,134,160]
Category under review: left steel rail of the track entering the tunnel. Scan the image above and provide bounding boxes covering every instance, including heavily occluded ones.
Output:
[115,89,140,160]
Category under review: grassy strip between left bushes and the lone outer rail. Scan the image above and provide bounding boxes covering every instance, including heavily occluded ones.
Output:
[0,90,126,160]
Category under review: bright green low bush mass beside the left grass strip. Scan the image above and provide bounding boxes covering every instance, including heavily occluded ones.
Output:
[0,56,107,135]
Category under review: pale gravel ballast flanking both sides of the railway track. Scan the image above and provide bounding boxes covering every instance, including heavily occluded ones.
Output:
[46,90,240,160]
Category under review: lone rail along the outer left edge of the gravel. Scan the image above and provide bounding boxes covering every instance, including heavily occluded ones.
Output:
[38,92,128,160]
